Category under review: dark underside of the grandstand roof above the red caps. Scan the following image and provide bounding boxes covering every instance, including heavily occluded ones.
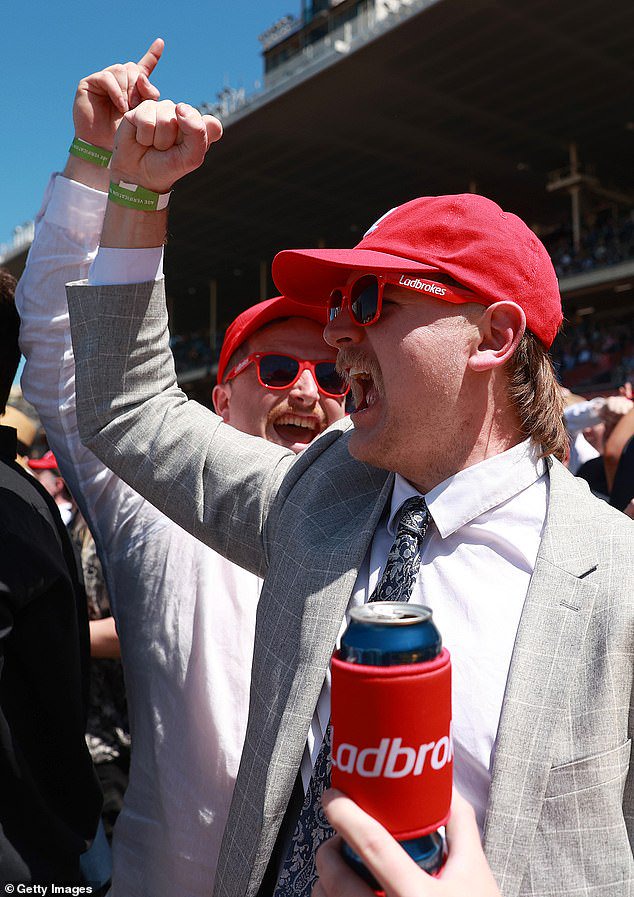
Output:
[166,0,634,323]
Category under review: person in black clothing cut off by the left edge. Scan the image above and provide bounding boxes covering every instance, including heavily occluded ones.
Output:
[0,272,101,884]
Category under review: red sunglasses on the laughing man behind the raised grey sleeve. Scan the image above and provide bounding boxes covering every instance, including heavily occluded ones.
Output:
[225,352,350,399]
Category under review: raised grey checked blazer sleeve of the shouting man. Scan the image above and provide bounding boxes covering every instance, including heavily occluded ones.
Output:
[67,281,295,575]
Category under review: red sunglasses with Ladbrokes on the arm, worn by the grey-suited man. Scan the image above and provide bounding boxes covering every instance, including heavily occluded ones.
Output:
[327,274,482,327]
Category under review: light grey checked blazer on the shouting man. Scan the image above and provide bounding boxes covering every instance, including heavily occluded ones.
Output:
[68,276,634,897]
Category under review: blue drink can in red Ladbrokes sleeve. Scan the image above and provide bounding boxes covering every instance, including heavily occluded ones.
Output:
[331,602,453,887]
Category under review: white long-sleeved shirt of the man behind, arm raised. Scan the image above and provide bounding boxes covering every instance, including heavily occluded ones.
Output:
[16,175,261,897]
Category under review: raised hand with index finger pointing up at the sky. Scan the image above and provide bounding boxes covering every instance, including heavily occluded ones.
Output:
[73,37,164,150]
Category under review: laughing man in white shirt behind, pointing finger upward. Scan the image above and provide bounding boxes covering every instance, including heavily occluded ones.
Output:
[16,50,347,897]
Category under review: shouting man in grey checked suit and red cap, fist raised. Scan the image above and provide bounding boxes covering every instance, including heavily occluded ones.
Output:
[68,101,634,897]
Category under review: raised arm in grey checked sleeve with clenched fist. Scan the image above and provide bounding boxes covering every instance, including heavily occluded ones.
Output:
[68,101,294,574]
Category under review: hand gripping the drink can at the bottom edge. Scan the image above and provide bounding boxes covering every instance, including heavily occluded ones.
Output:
[313,790,500,897]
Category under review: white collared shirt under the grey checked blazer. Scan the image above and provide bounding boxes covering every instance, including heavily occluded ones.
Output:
[302,440,548,829]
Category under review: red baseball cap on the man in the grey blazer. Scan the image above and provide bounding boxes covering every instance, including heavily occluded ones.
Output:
[273,193,562,348]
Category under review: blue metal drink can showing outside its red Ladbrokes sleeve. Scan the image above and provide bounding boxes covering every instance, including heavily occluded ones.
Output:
[340,601,445,890]
